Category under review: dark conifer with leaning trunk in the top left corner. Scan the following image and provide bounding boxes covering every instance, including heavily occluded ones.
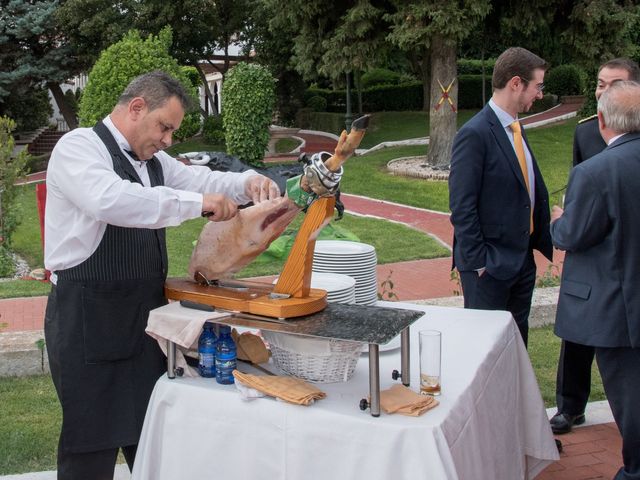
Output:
[0,0,84,128]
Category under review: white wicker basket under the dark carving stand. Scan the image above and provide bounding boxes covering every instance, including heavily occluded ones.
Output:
[262,330,362,383]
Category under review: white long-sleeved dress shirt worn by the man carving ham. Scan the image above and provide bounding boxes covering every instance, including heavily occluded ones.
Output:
[44,116,256,283]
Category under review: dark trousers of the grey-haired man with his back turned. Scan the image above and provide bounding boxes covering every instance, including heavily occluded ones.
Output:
[596,347,640,480]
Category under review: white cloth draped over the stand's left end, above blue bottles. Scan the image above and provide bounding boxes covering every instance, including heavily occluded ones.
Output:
[145,302,229,377]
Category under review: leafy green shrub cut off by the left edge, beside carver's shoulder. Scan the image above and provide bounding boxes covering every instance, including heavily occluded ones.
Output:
[0,116,28,277]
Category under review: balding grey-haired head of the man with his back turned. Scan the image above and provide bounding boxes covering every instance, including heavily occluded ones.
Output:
[598,80,640,133]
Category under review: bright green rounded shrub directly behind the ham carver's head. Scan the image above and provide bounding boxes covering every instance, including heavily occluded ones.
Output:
[79,27,200,139]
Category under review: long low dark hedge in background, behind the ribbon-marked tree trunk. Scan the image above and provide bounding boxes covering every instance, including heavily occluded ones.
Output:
[308,75,491,112]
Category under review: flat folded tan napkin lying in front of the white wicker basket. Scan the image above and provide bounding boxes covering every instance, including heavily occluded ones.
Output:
[233,370,327,405]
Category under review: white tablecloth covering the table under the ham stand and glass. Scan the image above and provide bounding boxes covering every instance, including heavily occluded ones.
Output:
[133,302,558,480]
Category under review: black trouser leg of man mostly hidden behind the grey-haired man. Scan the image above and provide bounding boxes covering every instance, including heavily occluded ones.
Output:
[556,340,595,415]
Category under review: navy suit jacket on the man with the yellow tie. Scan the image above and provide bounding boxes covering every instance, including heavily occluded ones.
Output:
[449,105,553,280]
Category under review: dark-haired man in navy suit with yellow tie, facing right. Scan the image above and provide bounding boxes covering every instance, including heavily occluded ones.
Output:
[449,47,553,345]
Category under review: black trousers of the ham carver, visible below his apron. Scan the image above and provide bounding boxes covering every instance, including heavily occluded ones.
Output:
[58,442,138,480]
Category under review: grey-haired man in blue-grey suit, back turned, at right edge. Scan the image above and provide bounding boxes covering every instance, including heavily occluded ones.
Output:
[551,81,640,480]
